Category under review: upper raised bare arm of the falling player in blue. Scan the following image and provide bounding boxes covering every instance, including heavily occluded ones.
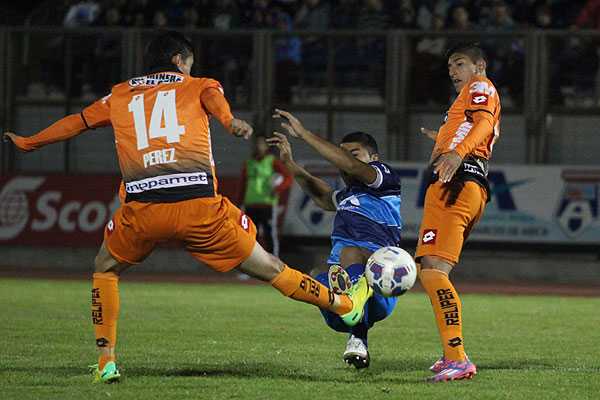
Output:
[273,109,377,184]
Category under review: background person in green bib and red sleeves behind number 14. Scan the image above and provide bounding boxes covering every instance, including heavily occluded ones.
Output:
[240,136,292,256]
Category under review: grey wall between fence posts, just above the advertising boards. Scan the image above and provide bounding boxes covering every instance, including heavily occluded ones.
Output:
[10,106,600,175]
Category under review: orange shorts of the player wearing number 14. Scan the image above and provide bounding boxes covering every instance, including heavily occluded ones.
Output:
[104,195,256,272]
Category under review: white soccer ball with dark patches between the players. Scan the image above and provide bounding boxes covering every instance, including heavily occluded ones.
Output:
[365,246,417,297]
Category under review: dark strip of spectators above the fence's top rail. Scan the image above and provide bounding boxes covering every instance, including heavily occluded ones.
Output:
[22,0,600,30]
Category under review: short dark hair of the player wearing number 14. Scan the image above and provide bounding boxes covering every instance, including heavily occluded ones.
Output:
[144,31,194,73]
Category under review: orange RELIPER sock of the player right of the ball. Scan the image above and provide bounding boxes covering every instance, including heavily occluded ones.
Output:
[419,269,466,361]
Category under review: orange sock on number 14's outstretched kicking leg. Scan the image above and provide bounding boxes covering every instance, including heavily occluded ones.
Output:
[271,266,352,315]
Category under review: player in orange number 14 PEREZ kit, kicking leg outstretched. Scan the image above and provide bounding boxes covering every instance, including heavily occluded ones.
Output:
[5,32,372,383]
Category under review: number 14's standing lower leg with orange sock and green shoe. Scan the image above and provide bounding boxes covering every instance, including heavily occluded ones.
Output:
[92,243,130,383]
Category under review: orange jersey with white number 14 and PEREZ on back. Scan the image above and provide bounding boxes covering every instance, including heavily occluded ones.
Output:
[82,72,233,202]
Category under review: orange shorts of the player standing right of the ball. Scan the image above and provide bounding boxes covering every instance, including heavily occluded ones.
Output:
[415,181,487,264]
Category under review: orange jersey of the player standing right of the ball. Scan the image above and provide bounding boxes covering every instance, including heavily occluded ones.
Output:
[431,76,501,161]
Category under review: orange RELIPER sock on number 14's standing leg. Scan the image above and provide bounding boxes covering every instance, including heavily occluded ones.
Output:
[92,272,120,369]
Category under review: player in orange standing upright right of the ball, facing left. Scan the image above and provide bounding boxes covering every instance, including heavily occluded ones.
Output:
[415,44,500,382]
